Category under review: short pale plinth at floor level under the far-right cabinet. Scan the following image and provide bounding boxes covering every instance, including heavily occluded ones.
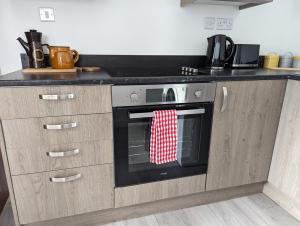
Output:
[263,183,300,221]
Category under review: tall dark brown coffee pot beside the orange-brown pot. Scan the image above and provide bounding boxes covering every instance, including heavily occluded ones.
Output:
[17,30,48,68]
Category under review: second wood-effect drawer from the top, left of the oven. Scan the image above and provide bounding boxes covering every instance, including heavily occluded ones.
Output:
[2,113,112,149]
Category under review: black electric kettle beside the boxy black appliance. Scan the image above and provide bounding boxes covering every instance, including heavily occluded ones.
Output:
[206,35,234,69]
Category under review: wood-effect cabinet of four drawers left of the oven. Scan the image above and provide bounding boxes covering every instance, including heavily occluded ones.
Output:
[0,85,114,225]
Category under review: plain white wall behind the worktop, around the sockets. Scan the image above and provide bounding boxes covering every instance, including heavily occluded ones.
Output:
[0,0,300,73]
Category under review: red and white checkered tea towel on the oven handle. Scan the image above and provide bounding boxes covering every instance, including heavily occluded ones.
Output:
[150,110,177,164]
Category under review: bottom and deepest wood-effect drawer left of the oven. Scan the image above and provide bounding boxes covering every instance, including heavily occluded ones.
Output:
[12,164,114,224]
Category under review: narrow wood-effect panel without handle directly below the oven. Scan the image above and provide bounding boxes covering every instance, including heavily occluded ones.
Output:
[115,174,206,208]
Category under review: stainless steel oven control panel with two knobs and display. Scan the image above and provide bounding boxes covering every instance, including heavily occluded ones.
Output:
[112,82,216,107]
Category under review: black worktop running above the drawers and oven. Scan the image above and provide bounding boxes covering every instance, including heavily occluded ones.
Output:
[0,69,300,86]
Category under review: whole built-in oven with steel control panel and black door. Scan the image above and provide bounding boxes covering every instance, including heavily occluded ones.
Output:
[112,83,216,187]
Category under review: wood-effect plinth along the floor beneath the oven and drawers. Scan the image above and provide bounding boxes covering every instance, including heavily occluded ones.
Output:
[26,183,264,226]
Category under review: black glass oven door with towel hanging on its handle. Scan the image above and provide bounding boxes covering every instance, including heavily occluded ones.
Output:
[113,103,213,187]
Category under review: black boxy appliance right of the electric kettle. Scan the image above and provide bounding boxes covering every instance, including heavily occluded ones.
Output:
[230,44,260,68]
